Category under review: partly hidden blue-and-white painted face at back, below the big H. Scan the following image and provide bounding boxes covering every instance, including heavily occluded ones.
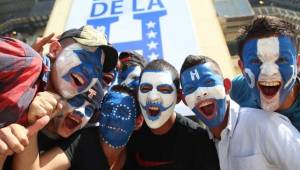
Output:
[118,66,142,89]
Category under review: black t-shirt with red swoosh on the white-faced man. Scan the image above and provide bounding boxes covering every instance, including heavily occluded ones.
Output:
[124,114,220,170]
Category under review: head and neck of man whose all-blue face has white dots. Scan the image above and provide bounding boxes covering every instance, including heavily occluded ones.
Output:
[99,85,142,170]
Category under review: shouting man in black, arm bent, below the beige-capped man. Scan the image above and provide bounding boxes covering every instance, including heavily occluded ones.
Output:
[13,81,103,170]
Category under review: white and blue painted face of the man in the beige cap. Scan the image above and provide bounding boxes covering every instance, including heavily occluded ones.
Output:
[51,43,104,99]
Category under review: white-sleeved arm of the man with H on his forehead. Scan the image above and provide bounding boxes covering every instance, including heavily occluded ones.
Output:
[260,113,300,170]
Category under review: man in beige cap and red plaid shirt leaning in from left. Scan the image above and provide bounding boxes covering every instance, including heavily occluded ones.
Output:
[0,26,118,154]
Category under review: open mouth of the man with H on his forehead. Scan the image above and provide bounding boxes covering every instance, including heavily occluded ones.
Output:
[196,99,217,119]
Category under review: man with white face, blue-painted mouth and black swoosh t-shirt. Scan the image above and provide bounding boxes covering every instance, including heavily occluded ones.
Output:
[128,60,219,170]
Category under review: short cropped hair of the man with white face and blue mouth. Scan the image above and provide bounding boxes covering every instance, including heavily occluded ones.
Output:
[140,59,179,92]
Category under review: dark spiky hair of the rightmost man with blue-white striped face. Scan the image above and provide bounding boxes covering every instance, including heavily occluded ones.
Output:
[237,16,299,60]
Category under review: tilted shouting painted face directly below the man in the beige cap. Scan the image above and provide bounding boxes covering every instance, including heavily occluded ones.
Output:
[55,81,104,137]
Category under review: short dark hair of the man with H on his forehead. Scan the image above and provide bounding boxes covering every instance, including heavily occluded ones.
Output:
[180,55,222,76]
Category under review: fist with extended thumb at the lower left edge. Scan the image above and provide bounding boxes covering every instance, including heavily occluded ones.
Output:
[0,116,50,155]
